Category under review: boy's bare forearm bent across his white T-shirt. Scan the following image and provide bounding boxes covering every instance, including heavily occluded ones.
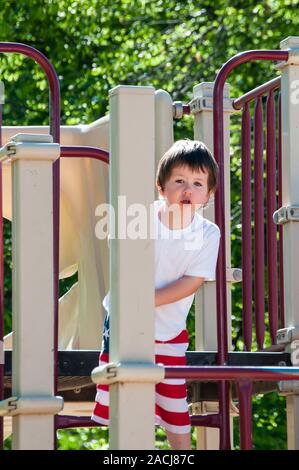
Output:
[155,276,205,307]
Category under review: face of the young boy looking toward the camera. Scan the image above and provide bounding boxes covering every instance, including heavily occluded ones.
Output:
[158,165,211,212]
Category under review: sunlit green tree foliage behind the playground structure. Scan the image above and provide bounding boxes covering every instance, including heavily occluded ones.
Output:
[0,0,299,448]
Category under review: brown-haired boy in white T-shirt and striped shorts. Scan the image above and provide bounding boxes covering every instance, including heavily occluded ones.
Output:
[92,140,220,450]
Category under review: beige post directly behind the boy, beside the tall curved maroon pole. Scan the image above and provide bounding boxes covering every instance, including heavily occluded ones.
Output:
[191,82,233,449]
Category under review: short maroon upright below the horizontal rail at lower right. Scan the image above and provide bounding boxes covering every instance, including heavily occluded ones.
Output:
[237,380,252,450]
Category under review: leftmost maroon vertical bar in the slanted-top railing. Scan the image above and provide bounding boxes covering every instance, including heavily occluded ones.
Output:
[242,103,252,351]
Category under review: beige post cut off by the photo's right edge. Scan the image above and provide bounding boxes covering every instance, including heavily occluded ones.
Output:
[278,37,299,450]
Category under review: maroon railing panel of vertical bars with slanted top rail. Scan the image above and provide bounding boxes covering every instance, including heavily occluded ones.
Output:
[233,77,284,351]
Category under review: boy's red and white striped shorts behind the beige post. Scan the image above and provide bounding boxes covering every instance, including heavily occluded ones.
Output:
[91,330,191,434]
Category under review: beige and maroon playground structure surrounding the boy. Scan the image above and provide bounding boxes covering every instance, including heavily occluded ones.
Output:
[0,38,299,449]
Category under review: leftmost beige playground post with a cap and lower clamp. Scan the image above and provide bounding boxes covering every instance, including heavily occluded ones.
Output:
[0,135,62,450]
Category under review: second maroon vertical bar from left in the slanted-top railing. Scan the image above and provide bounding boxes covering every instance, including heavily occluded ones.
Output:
[254,96,265,349]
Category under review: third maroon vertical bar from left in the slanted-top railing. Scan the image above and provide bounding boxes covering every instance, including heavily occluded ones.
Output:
[267,91,278,344]
